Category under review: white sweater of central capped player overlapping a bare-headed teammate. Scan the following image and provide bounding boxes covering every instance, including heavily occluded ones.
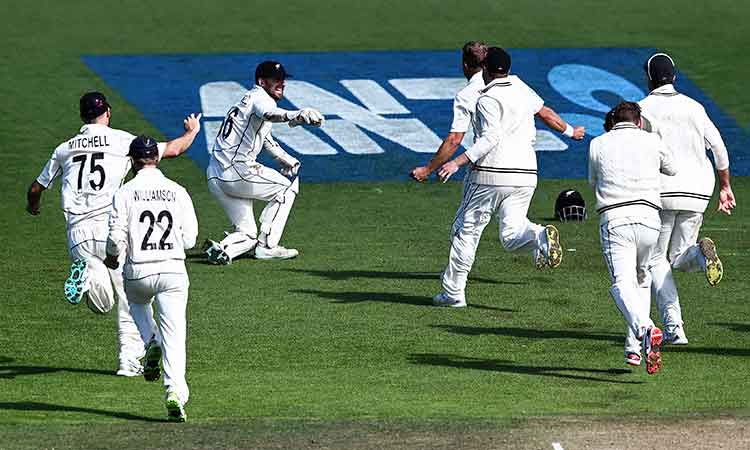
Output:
[466,75,544,186]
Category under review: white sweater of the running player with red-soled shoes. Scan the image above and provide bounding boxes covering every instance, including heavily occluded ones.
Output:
[589,122,675,223]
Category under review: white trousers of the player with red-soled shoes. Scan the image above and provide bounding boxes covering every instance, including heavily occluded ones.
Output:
[599,217,660,338]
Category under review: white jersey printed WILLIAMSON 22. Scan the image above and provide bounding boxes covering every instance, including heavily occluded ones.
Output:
[107,168,198,280]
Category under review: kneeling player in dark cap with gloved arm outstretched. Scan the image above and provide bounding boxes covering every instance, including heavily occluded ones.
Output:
[204,61,324,264]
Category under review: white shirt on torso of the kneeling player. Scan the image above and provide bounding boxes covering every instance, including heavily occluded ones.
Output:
[212,86,276,169]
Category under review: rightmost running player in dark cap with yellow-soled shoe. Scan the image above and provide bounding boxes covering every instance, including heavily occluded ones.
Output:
[626,53,736,353]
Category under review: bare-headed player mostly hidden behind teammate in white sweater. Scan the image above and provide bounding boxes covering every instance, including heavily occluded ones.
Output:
[410,41,487,182]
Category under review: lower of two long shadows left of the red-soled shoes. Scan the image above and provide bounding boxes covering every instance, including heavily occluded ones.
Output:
[409,353,643,384]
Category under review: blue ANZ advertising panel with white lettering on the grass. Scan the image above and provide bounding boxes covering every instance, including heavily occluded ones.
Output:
[83,48,750,182]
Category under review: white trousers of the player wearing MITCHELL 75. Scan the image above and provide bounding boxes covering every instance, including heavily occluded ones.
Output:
[68,221,144,365]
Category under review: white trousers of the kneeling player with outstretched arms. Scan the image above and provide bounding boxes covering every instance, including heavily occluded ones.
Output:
[206,159,299,258]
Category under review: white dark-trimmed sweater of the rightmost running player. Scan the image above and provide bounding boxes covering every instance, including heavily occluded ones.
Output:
[639,84,729,213]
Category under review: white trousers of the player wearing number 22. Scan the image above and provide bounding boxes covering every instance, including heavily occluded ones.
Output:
[125,273,190,404]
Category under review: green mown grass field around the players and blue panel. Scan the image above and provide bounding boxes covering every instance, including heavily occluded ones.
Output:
[0,0,750,449]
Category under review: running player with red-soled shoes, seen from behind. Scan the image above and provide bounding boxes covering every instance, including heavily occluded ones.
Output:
[589,102,676,374]
